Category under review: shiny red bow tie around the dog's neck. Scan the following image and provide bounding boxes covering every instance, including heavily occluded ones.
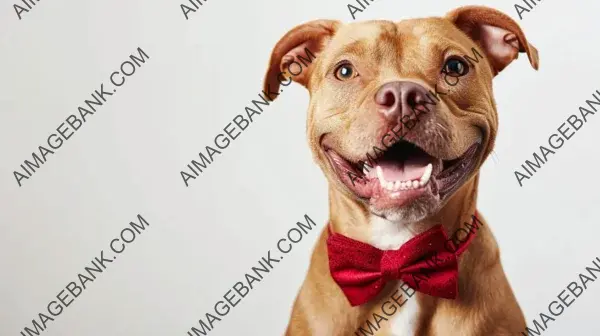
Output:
[327,218,475,306]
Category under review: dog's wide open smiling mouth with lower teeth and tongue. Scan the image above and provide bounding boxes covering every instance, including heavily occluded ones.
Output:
[324,140,480,208]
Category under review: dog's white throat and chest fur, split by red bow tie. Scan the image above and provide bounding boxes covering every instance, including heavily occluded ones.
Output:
[369,216,419,336]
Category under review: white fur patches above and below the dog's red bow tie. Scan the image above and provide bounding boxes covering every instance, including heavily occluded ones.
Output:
[370,217,420,336]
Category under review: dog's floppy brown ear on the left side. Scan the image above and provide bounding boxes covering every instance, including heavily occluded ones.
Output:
[264,20,341,100]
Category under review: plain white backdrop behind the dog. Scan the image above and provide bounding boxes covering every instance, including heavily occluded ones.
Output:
[0,0,600,336]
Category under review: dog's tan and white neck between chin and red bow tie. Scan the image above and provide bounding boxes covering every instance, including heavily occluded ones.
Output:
[329,174,479,250]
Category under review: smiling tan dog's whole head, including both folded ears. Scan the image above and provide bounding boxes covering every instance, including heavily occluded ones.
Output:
[265,6,538,221]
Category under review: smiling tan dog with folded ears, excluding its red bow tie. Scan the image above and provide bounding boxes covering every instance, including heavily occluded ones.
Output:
[265,6,538,336]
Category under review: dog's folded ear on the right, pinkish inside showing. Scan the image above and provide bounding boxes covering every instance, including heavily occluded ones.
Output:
[446,6,539,75]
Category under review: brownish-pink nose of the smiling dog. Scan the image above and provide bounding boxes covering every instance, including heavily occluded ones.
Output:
[375,81,428,120]
